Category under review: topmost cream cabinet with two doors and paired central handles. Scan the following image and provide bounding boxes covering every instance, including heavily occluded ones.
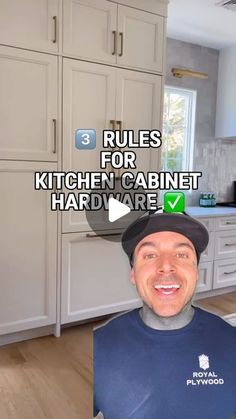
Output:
[63,0,164,73]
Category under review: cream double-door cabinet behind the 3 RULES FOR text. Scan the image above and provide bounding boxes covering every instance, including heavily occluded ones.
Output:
[62,59,162,232]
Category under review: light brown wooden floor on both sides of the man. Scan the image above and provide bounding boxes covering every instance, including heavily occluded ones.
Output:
[0,292,236,419]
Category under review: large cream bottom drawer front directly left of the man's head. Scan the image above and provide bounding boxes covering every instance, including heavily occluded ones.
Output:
[61,233,141,323]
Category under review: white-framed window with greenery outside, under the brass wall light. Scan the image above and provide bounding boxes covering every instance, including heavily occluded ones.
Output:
[161,86,197,172]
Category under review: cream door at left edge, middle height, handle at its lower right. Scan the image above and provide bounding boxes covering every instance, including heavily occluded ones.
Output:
[0,46,57,161]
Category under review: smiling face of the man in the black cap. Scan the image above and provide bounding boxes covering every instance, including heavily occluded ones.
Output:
[131,231,198,317]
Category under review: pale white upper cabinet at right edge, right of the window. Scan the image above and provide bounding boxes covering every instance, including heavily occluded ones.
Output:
[215,47,236,138]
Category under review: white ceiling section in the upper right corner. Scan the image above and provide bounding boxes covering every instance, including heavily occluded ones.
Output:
[167,0,236,49]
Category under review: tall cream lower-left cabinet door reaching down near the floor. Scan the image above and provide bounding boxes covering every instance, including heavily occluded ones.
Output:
[0,162,57,334]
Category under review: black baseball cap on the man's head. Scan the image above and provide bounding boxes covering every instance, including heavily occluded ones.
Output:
[121,210,209,265]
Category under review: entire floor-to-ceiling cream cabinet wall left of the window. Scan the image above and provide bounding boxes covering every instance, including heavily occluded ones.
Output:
[0,0,168,342]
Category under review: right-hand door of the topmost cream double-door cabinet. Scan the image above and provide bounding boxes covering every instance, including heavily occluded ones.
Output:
[117,5,164,73]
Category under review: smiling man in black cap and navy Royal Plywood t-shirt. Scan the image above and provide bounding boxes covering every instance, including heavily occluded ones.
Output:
[94,213,236,419]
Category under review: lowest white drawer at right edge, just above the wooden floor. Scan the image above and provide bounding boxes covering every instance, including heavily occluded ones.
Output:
[213,258,236,288]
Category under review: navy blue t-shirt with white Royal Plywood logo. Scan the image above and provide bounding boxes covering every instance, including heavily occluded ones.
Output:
[94,308,236,419]
